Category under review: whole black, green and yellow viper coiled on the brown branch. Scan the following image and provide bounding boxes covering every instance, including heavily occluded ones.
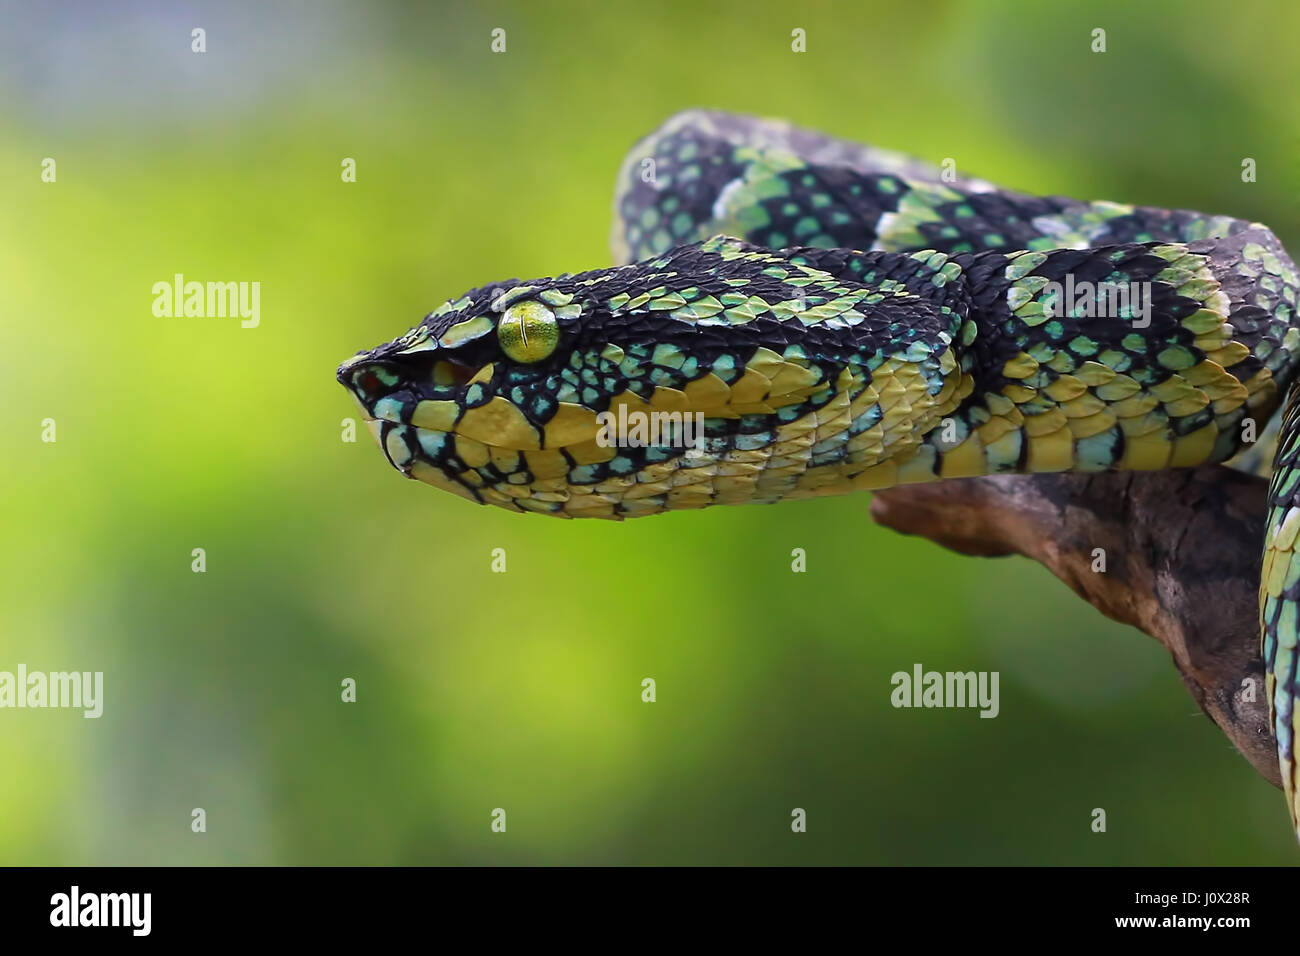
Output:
[338,111,1300,842]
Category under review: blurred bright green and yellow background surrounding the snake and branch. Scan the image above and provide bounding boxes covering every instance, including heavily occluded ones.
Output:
[0,0,1300,864]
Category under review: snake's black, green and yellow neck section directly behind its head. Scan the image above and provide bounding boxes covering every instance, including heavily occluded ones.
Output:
[794,226,1300,486]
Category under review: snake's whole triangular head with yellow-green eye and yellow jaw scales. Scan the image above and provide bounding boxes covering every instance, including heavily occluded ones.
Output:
[338,237,944,518]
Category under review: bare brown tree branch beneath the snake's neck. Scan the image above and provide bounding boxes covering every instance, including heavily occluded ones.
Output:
[871,466,1282,787]
